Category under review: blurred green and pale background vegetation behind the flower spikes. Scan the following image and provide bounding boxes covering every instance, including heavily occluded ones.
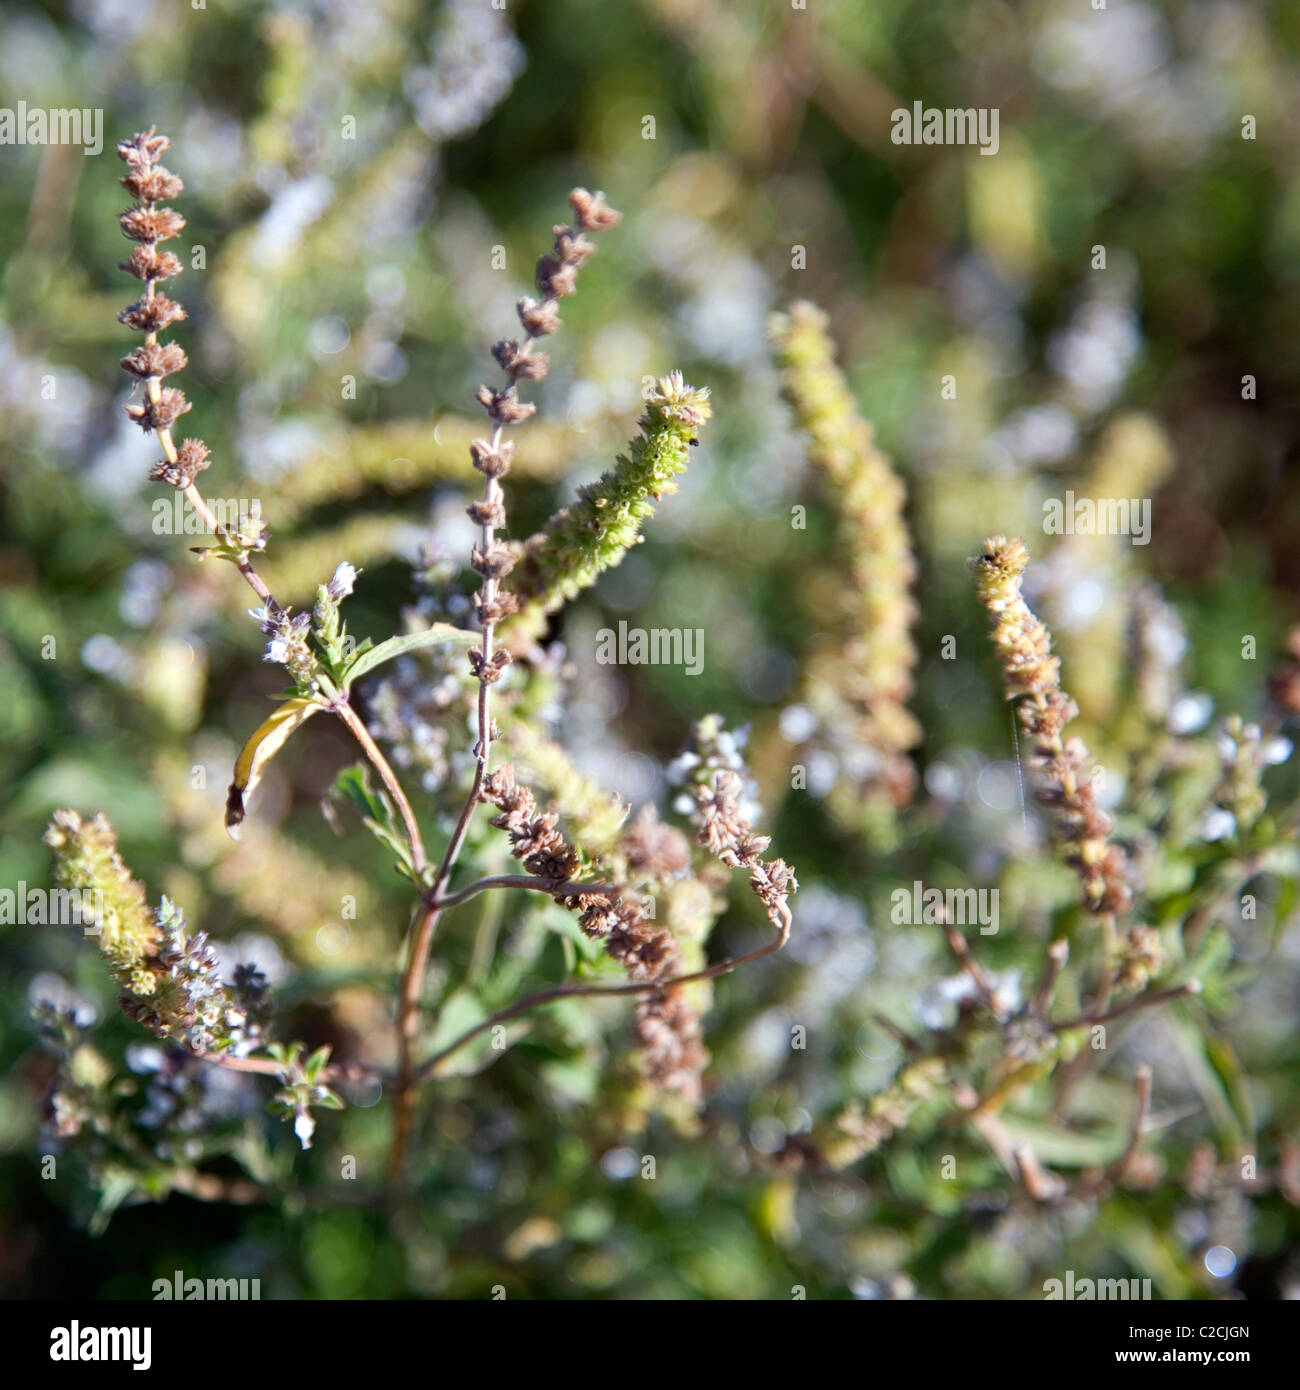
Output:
[0,0,1300,1298]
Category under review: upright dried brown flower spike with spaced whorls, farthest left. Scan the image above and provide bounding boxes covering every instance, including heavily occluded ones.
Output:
[117,129,209,488]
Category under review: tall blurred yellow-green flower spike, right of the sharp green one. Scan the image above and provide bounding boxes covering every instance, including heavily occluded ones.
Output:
[769,300,920,809]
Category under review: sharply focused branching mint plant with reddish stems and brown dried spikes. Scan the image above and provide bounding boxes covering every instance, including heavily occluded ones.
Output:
[38,131,797,1183]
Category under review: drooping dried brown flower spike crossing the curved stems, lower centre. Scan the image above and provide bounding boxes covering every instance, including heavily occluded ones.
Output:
[482,763,708,1104]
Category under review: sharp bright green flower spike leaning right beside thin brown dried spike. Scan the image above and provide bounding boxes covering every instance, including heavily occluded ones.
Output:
[516,371,713,635]
